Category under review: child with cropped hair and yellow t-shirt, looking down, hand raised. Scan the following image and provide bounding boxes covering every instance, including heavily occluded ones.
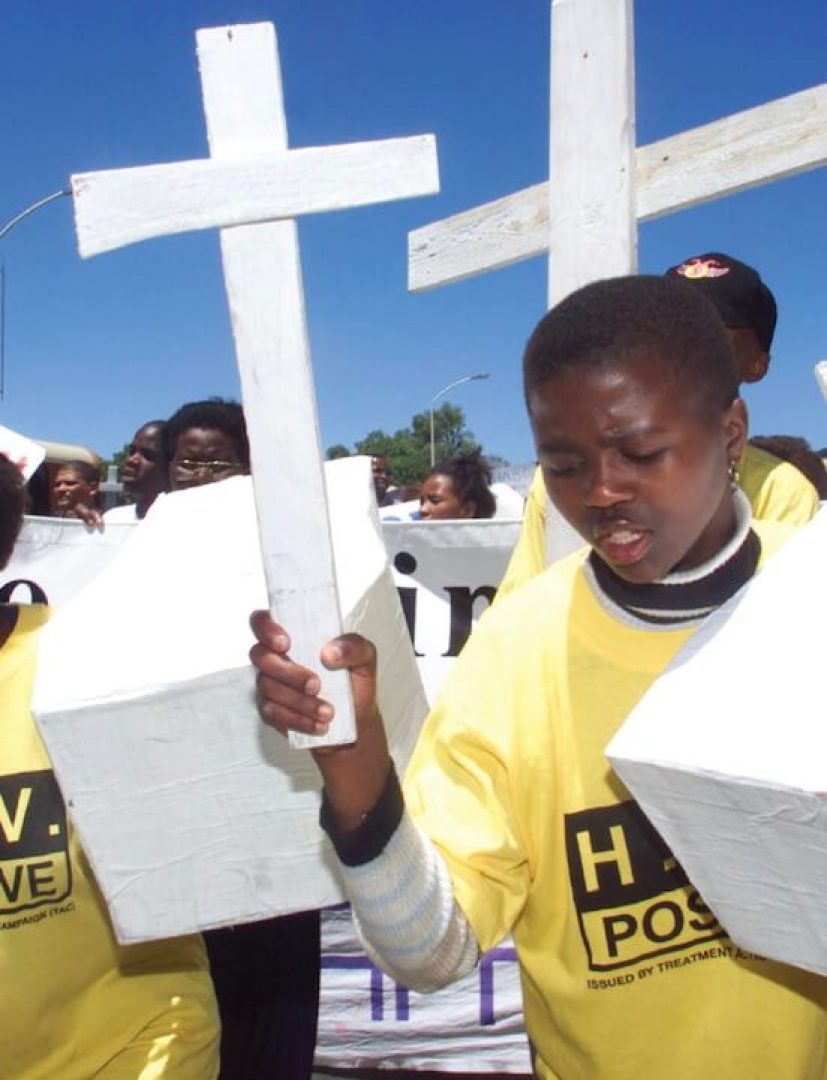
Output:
[252,278,827,1080]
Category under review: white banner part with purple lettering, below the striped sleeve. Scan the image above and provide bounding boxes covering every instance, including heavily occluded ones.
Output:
[314,908,531,1077]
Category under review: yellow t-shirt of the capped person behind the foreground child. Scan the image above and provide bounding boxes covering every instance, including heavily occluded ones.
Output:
[497,443,819,600]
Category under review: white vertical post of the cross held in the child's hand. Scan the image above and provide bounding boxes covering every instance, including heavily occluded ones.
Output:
[196,25,355,744]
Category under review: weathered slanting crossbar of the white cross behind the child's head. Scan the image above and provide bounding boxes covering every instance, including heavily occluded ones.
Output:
[408,84,827,292]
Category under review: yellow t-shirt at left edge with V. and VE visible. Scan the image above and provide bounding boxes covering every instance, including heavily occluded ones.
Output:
[0,606,218,1080]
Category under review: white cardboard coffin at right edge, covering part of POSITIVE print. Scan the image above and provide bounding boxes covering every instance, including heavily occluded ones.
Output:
[607,511,827,974]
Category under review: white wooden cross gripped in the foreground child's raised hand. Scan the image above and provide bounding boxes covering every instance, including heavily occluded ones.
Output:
[72,24,438,745]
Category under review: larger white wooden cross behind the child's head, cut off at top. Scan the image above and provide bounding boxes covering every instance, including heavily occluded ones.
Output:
[408,0,827,562]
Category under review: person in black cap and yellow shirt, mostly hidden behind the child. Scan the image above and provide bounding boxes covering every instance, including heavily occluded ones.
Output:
[497,252,819,597]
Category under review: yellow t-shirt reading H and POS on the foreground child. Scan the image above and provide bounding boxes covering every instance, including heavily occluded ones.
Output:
[405,525,827,1080]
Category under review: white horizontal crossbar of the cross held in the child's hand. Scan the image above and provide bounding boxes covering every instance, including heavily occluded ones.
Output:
[71,135,439,256]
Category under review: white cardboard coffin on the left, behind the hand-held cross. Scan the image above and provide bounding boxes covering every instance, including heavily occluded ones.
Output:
[35,458,426,943]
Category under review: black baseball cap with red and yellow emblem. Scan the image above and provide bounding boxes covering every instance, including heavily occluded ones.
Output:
[665,252,778,352]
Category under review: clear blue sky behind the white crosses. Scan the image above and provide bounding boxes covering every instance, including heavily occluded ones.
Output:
[0,0,827,462]
